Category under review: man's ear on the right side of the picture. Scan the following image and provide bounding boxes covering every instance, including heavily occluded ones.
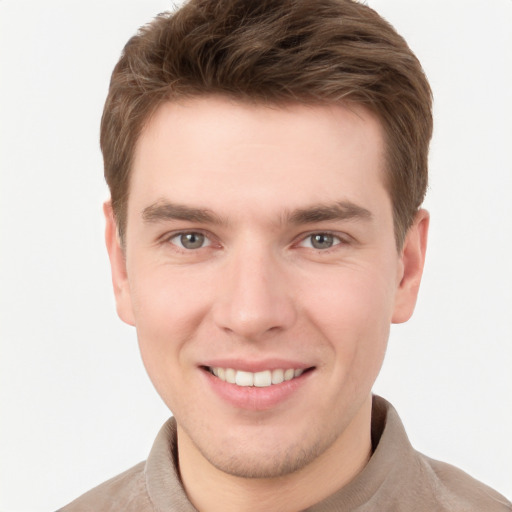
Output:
[391,210,430,324]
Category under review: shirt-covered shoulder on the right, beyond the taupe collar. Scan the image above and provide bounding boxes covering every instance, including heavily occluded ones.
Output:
[418,454,512,512]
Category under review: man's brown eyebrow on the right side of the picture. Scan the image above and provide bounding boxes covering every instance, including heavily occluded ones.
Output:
[285,201,373,224]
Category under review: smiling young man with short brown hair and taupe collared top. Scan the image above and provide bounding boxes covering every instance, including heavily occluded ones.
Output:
[59,0,511,512]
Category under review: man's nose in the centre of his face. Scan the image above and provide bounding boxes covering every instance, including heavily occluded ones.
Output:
[213,244,296,340]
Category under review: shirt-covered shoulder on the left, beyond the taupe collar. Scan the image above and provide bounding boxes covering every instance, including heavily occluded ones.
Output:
[58,462,153,512]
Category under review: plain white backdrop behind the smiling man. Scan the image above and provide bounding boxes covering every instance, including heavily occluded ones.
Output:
[0,0,512,512]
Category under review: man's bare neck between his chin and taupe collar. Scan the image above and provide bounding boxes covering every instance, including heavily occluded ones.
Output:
[178,396,371,512]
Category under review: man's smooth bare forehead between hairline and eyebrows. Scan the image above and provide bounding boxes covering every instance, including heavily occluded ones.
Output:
[129,97,384,221]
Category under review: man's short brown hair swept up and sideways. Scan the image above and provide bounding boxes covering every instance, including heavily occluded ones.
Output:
[101,0,432,248]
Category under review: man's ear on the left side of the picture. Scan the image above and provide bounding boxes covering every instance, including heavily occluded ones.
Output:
[103,201,135,325]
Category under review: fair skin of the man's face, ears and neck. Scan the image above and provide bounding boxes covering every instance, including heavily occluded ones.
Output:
[105,97,428,512]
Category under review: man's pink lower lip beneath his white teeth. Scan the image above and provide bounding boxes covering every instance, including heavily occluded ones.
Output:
[202,369,313,411]
